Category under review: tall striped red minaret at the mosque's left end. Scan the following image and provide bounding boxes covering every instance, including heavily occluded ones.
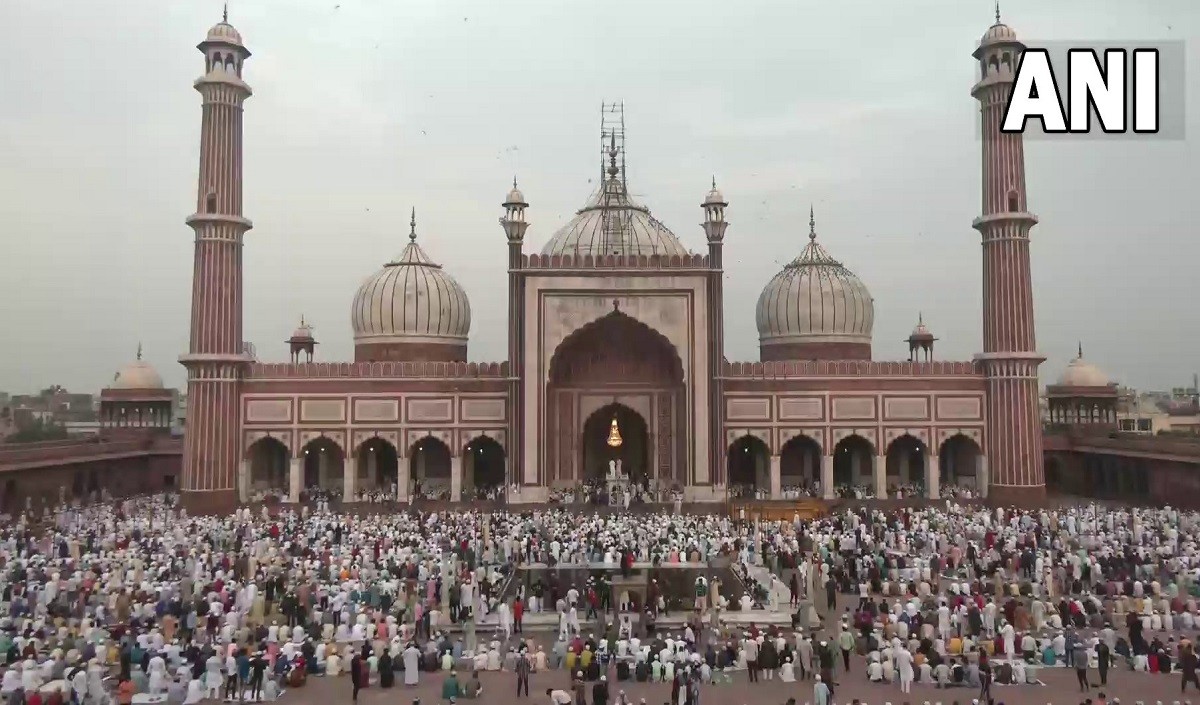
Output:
[180,14,252,513]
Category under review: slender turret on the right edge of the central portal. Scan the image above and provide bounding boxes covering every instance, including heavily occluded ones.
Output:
[700,176,730,487]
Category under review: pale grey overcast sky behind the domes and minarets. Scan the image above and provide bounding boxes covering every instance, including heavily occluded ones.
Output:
[0,0,1200,392]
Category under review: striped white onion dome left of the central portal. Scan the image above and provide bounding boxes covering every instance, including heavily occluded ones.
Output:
[350,209,470,361]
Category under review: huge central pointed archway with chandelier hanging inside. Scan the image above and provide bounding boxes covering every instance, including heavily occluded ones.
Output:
[545,311,689,487]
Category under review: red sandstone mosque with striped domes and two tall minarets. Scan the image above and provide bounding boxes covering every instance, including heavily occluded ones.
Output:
[162,8,1045,512]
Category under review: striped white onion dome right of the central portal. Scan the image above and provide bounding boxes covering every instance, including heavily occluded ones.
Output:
[755,203,875,361]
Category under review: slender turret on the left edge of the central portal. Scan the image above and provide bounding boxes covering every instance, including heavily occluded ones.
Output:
[500,176,529,484]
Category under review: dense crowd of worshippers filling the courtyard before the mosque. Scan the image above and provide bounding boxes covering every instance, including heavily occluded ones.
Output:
[0,493,1200,705]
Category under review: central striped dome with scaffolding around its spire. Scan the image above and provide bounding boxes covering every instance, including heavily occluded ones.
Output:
[541,138,691,257]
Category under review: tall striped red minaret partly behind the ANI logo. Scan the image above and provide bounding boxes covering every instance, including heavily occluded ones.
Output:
[971,6,1045,504]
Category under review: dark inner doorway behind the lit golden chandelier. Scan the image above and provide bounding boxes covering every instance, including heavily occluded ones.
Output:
[580,404,650,484]
